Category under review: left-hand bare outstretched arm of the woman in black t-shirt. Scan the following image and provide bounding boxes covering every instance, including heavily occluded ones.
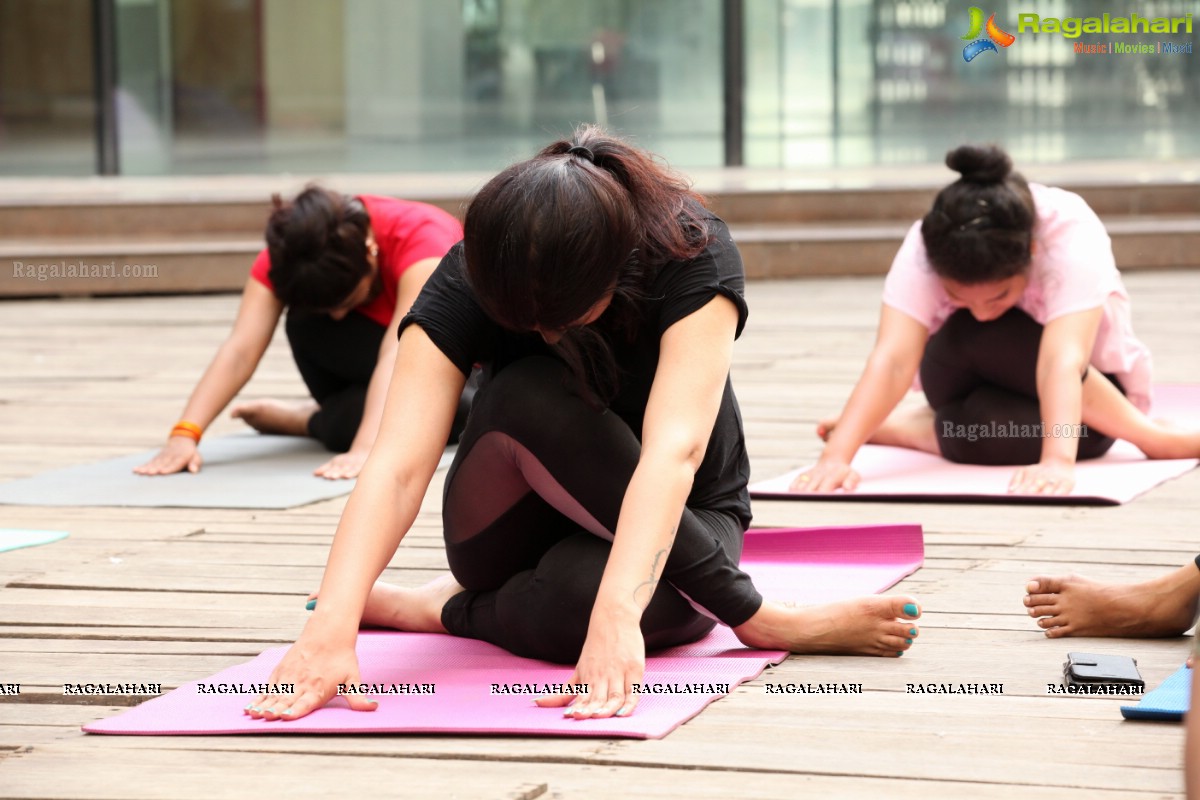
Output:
[258,325,467,720]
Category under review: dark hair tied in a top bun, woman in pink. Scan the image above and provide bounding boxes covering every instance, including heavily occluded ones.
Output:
[920,144,1036,285]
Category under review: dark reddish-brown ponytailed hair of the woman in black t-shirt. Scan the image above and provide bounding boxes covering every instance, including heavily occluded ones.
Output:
[463,125,710,399]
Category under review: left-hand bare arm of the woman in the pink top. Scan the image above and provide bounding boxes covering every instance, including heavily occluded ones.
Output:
[792,305,929,492]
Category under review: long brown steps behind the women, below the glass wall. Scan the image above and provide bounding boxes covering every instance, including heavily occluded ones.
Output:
[0,162,1200,296]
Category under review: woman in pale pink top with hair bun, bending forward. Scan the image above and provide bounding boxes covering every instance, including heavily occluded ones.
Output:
[792,145,1200,494]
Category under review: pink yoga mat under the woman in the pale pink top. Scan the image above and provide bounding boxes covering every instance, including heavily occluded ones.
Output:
[750,385,1200,505]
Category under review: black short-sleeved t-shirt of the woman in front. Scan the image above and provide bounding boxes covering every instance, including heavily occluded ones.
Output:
[400,217,750,527]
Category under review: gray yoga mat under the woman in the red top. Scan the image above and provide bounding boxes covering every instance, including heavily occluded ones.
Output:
[0,433,454,509]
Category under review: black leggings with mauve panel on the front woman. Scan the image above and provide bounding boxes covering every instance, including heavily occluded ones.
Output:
[442,357,762,663]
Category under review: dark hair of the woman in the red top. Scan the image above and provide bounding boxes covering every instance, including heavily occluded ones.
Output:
[266,186,371,311]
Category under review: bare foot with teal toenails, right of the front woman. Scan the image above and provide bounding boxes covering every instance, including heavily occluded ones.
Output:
[733,595,920,657]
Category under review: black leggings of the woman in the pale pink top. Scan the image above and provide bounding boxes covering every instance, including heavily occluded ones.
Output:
[920,308,1121,465]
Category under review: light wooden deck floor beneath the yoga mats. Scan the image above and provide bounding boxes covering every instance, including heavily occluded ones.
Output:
[0,271,1200,800]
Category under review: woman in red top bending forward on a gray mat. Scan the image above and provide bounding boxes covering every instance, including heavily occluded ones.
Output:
[134,187,462,479]
